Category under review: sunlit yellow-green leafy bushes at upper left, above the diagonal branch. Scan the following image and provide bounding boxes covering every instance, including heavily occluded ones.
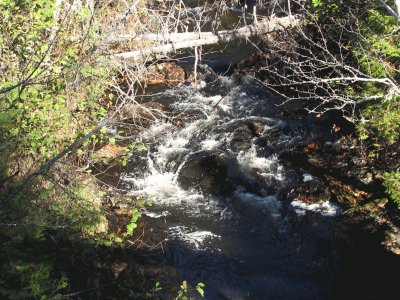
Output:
[0,0,110,162]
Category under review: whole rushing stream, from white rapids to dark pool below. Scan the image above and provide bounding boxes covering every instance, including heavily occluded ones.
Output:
[116,71,356,299]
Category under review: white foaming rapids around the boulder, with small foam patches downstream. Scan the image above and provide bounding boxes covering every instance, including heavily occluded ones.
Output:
[122,76,338,250]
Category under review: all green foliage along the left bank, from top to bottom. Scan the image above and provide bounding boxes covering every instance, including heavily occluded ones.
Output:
[0,0,118,299]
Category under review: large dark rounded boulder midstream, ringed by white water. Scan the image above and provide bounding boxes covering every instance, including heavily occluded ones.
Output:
[178,151,251,194]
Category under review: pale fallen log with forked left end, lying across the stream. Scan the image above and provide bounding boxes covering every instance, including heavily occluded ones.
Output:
[113,16,301,61]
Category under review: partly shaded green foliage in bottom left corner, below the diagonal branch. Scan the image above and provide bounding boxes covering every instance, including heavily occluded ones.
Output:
[0,173,107,299]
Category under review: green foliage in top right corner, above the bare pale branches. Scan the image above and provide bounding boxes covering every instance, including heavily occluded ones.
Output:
[311,0,400,81]
